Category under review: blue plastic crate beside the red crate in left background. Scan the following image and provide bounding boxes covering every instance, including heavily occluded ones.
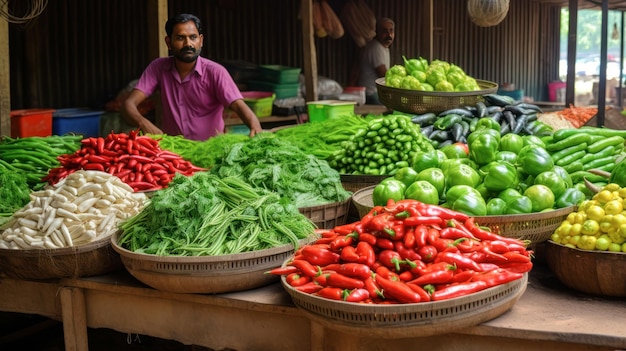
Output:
[52,108,104,138]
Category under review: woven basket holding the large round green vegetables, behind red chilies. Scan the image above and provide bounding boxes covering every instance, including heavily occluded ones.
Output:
[352,185,575,245]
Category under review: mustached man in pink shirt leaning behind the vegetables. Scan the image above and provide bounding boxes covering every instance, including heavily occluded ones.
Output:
[122,14,262,141]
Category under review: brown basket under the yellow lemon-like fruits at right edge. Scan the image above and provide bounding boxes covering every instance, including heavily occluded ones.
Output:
[545,240,626,297]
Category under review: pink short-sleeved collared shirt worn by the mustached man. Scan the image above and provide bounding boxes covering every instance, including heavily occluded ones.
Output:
[135,56,243,141]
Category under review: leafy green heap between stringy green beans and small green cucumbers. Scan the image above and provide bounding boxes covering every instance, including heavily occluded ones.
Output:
[210,133,351,208]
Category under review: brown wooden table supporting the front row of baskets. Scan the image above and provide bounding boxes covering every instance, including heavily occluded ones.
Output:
[0,264,626,351]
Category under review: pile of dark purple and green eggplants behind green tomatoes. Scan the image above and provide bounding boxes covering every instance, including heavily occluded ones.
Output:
[411,94,554,148]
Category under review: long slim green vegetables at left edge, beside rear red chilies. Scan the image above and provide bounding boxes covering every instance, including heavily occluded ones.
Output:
[0,134,83,190]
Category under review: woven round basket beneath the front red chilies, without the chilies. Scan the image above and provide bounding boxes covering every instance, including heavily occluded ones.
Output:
[281,273,528,338]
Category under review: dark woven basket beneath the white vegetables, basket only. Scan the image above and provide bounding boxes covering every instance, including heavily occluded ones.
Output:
[0,236,123,280]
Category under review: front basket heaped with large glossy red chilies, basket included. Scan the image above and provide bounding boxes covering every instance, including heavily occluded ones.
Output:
[269,200,532,338]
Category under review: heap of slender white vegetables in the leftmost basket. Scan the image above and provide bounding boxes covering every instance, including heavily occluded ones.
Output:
[0,170,146,249]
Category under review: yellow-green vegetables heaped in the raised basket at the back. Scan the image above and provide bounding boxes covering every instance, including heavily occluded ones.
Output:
[385,56,480,92]
